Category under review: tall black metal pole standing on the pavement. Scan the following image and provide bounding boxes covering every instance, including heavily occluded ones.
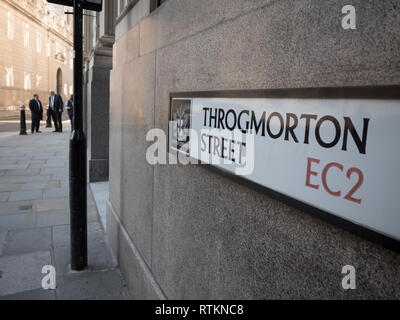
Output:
[69,0,87,271]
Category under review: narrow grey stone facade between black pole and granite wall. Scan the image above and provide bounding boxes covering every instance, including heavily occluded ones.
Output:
[84,1,117,182]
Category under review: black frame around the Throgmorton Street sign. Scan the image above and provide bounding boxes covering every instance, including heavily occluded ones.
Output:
[168,85,400,253]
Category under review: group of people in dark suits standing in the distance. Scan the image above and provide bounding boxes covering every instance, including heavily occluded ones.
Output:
[29,90,74,133]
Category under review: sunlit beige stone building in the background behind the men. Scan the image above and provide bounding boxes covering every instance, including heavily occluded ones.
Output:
[0,0,73,117]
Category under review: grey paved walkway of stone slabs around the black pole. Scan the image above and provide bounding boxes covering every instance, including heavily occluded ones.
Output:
[0,122,129,300]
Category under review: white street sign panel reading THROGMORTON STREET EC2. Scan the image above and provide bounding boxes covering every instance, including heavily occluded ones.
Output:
[171,98,400,240]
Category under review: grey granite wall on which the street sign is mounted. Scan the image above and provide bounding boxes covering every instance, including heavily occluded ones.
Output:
[107,0,400,299]
